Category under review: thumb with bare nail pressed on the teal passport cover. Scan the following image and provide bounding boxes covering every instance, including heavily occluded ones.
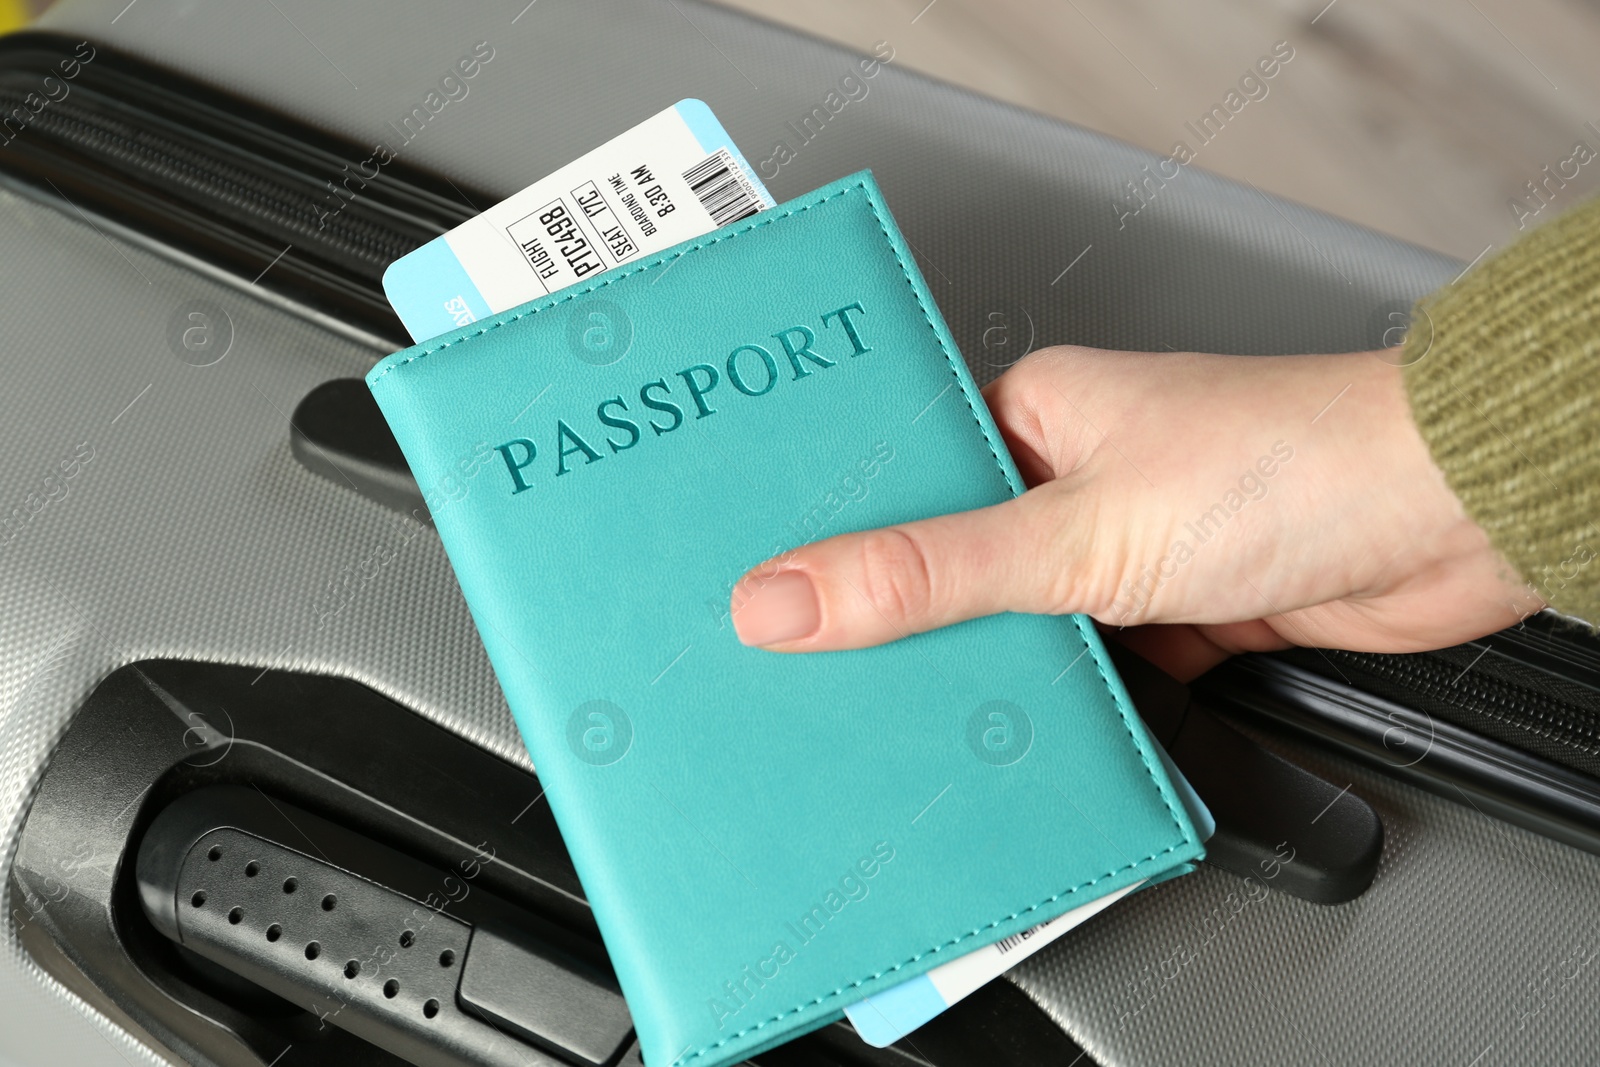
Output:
[730,490,1088,653]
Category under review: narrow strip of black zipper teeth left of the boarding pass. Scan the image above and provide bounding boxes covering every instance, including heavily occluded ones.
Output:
[0,90,414,266]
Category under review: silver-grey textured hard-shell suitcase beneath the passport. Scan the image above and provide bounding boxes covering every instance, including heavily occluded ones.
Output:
[0,0,1600,1064]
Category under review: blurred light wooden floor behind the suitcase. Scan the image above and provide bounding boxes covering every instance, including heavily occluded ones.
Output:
[722,0,1600,259]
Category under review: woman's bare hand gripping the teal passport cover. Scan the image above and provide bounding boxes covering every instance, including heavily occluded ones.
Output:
[733,347,1542,678]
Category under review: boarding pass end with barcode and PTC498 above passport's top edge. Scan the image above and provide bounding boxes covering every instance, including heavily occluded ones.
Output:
[384,99,773,341]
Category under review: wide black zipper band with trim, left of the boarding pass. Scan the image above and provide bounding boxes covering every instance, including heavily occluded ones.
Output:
[0,34,493,350]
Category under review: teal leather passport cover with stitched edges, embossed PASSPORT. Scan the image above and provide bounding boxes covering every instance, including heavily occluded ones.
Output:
[366,173,1202,1067]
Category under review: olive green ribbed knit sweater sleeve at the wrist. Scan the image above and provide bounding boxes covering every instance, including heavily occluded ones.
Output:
[1405,198,1600,622]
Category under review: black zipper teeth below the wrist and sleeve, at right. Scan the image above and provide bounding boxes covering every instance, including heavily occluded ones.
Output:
[1328,649,1600,755]
